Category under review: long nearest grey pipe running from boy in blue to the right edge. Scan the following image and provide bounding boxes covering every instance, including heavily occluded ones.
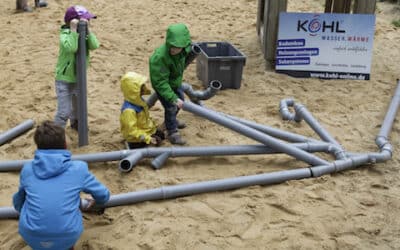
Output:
[0,80,399,218]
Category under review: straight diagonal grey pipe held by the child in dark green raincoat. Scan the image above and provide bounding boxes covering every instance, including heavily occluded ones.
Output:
[183,102,328,168]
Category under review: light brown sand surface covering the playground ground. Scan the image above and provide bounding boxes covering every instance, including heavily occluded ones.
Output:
[0,0,400,250]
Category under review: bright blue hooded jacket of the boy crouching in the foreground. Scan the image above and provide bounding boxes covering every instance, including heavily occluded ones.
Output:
[13,149,110,249]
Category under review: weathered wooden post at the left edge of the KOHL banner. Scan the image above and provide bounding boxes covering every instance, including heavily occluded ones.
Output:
[258,0,287,64]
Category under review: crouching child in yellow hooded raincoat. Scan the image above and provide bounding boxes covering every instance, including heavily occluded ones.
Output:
[119,72,164,149]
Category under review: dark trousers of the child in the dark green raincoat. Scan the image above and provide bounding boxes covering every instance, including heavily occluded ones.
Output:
[156,87,185,135]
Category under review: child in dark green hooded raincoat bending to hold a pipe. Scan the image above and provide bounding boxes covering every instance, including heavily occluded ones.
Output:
[149,23,192,145]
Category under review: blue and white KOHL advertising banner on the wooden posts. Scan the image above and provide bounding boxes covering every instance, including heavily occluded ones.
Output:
[275,12,375,80]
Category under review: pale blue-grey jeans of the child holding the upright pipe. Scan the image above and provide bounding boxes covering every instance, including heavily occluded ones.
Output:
[54,80,78,127]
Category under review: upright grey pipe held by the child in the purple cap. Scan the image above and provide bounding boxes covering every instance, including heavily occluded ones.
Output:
[76,21,89,147]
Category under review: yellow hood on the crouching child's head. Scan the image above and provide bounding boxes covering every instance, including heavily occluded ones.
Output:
[121,72,151,107]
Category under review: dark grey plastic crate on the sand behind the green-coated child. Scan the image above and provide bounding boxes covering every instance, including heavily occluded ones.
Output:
[196,42,246,89]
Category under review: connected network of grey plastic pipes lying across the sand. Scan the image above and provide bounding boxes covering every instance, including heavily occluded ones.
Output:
[0,80,400,218]
